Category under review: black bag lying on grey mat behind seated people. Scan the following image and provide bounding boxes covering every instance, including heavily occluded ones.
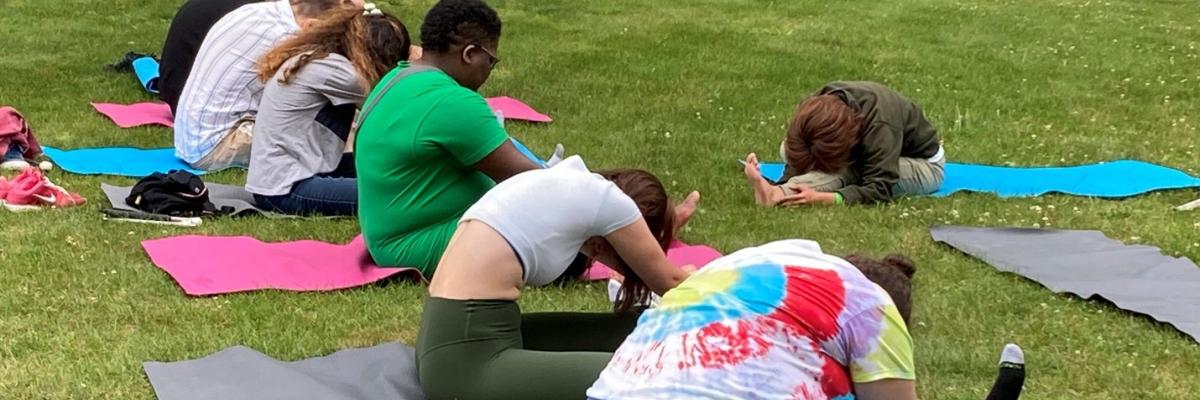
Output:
[125,171,221,216]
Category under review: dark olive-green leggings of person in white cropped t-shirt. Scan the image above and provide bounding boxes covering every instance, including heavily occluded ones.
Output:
[416,297,637,400]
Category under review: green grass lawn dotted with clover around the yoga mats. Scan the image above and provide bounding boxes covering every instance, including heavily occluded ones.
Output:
[0,0,1200,399]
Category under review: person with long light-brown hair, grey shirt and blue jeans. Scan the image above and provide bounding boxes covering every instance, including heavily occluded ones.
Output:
[246,4,410,215]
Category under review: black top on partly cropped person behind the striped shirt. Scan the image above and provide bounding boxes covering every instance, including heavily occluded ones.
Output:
[158,0,259,113]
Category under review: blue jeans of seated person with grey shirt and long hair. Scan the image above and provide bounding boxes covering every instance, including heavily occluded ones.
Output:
[254,175,359,215]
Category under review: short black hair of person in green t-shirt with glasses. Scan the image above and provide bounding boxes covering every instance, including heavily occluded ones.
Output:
[421,0,500,52]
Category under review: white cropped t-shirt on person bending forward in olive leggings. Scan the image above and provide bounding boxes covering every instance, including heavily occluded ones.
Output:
[461,156,642,286]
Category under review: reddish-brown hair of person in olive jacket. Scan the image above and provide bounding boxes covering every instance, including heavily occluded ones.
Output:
[784,95,862,174]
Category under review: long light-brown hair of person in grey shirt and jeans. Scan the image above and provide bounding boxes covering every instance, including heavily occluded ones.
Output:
[258,7,412,90]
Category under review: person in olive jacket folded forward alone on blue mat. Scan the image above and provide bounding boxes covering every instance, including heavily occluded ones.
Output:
[745,82,946,207]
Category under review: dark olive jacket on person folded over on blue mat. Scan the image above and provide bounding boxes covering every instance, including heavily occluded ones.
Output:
[780,82,941,204]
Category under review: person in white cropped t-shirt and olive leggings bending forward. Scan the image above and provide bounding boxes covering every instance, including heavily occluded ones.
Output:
[416,156,688,400]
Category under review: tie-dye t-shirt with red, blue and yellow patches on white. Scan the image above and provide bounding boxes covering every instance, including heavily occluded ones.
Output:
[588,240,916,400]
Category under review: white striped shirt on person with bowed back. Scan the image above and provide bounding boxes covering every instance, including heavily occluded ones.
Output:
[175,0,300,163]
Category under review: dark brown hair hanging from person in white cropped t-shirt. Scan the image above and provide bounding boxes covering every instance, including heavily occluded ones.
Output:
[589,169,674,311]
